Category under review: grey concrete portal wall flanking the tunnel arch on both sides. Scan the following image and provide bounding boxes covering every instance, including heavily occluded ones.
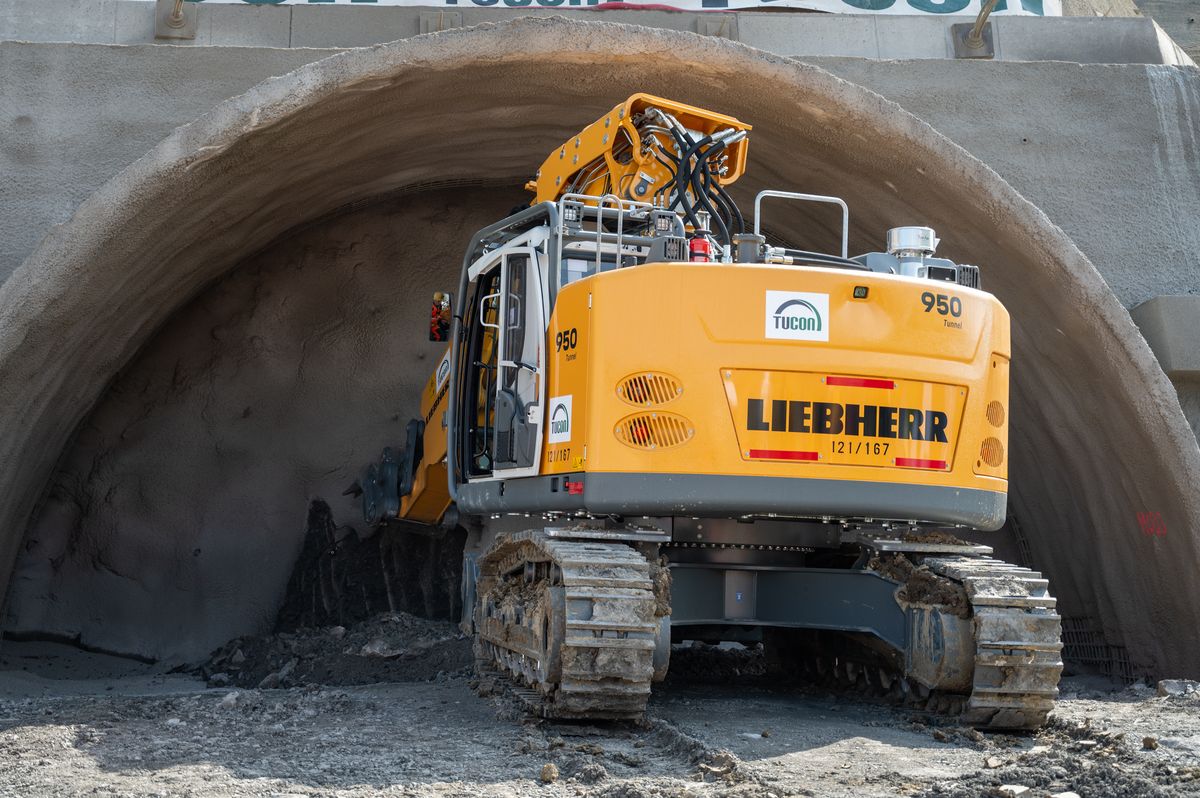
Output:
[0,42,1200,306]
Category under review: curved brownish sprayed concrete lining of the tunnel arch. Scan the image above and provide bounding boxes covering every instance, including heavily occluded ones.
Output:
[0,19,1200,676]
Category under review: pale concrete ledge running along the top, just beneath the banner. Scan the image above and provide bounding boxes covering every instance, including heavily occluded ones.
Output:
[0,0,1187,64]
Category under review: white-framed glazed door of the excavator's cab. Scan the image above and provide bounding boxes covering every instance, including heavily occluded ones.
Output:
[492,248,547,476]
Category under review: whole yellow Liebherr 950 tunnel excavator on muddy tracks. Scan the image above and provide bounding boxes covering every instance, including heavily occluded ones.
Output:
[359,94,1062,728]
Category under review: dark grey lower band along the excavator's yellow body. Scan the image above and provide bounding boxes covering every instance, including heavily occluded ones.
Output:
[458,473,1008,532]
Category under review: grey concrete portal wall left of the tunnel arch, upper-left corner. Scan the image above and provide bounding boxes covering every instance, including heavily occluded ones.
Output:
[0,42,330,280]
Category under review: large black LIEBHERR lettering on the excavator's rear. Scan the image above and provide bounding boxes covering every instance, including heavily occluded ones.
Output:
[746,398,949,443]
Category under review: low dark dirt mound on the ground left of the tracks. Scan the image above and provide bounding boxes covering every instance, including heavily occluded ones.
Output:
[198,612,473,688]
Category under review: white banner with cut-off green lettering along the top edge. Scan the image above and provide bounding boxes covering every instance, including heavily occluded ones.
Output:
[188,0,1062,17]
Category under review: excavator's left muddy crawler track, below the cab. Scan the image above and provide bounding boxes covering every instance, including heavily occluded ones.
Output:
[475,530,659,719]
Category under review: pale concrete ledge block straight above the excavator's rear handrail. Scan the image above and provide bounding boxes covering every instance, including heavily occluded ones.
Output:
[738,13,878,58]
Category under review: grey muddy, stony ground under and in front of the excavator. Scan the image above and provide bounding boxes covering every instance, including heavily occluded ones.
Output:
[0,641,1200,798]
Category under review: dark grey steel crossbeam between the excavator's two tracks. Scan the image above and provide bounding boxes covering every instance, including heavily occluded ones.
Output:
[671,565,908,650]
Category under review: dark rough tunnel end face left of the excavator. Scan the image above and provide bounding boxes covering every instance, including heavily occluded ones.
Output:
[8,188,521,659]
